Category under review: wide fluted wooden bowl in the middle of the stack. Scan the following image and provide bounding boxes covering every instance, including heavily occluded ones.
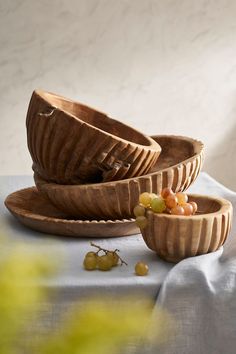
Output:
[35,136,203,219]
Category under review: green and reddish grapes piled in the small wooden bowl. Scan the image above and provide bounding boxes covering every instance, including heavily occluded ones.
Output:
[134,188,198,229]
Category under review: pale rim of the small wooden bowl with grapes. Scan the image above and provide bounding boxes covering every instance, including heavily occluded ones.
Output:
[147,193,233,221]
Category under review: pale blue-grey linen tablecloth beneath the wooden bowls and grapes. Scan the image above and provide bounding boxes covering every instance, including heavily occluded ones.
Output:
[0,173,236,354]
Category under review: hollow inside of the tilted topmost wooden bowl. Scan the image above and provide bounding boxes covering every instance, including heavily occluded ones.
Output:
[37,91,151,146]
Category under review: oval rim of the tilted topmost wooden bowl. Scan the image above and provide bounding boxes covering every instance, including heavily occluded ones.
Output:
[31,89,162,154]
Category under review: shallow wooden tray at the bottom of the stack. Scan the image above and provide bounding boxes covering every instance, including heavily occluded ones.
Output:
[5,187,139,237]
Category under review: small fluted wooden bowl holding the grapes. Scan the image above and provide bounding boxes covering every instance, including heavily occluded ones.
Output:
[141,195,233,263]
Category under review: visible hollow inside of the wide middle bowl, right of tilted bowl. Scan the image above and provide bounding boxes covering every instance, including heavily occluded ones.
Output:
[150,135,198,173]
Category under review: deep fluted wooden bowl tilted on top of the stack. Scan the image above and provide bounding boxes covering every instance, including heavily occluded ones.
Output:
[26,90,161,184]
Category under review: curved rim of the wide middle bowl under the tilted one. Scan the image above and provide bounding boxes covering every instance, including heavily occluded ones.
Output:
[34,134,204,190]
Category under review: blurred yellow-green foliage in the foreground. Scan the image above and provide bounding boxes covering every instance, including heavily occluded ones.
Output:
[0,235,170,354]
